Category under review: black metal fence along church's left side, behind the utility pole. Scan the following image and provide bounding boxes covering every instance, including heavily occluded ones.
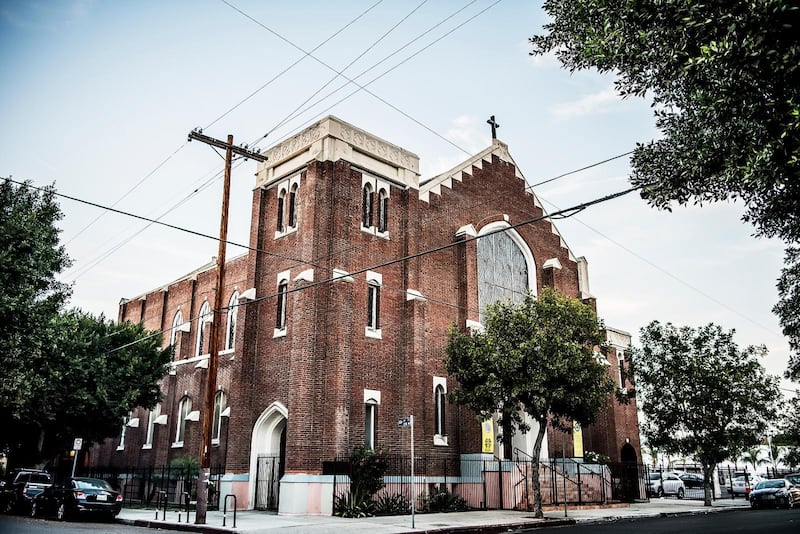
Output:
[81,465,223,510]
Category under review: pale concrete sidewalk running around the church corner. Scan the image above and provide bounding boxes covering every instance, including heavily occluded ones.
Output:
[118,498,749,534]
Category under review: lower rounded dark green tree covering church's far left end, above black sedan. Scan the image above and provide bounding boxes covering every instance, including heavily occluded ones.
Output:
[8,310,172,464]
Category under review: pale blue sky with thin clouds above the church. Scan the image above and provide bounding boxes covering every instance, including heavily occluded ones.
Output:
[0,0,796,398]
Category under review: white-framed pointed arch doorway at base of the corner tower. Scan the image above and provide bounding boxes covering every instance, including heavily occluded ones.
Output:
[250,403,288,512]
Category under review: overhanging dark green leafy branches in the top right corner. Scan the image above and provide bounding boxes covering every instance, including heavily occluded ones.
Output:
[530,0,800,377]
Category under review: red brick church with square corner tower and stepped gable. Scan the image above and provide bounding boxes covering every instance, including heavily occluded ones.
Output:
[89,116,641,514]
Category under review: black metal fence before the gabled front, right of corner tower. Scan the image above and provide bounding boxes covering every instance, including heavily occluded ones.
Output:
[323,455,647,511]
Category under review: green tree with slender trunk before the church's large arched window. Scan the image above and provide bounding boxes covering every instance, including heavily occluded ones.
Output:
[445,288,614,517]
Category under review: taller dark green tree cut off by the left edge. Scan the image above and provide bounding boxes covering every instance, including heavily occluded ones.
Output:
[0,179,70,422]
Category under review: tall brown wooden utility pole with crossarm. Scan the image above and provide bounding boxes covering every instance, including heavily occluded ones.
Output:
[189,130,267,525]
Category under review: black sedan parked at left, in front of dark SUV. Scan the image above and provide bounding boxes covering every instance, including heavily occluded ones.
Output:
[31,477,122,520]
